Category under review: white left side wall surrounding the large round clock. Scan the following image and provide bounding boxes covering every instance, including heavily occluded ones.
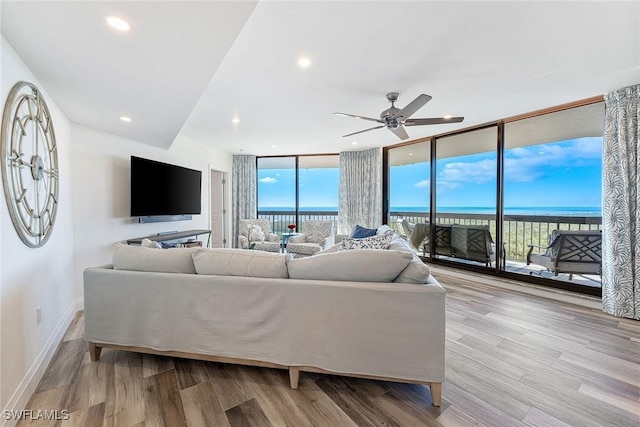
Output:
[0,37,75,418]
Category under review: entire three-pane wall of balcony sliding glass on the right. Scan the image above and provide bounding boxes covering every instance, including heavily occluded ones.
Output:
[384,99,604,295]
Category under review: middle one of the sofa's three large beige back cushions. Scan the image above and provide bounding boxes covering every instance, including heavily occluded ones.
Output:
[193,248,289,279]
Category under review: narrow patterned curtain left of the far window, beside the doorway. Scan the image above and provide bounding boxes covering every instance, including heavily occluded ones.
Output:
[231,155,258,248]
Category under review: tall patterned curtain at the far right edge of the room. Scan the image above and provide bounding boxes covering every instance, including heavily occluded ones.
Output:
[602,85,640,320]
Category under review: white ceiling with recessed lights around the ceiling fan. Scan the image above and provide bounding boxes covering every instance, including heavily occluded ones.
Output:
[0,0,640,155]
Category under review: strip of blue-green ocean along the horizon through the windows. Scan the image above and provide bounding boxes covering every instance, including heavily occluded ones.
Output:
[258,206,602,216]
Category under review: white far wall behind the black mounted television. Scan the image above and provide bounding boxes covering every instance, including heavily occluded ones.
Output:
[71,124,232,296]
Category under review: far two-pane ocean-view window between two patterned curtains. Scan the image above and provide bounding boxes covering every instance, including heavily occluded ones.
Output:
[258,154,340,233]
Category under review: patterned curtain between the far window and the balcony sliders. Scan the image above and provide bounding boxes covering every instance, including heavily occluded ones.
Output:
[338,148,382,234]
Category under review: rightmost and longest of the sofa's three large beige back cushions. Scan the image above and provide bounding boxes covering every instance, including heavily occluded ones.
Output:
[288,249,411,282]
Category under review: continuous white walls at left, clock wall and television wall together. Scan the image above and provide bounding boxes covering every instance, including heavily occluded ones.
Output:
[0,37,232,425]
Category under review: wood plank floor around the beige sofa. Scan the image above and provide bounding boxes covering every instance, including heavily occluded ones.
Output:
[19,274,640,427]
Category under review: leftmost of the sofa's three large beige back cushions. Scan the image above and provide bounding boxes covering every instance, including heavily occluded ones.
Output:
[113,244,200,274]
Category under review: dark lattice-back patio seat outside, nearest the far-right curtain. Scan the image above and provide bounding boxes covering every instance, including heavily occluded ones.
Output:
[527,230,602,280]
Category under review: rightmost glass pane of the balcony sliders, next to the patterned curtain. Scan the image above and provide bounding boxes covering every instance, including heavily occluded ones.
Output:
[503,103,604,287]
